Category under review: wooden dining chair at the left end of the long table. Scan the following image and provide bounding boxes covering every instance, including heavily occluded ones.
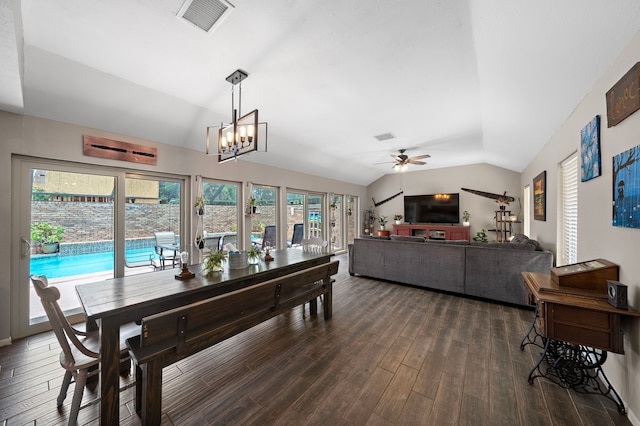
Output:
[31,275,140,425]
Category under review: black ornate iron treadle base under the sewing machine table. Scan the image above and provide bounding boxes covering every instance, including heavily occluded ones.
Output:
[520,306,626,415]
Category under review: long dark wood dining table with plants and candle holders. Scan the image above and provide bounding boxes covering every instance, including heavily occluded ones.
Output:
[76,249,331,425]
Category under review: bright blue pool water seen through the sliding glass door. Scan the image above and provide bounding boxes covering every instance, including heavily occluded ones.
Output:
[31,248,157,278]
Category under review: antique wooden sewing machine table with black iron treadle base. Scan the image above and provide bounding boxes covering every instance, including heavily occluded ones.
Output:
[520,272,640,414]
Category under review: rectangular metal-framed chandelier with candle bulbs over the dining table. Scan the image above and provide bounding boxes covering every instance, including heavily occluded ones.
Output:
[206,69,267,163]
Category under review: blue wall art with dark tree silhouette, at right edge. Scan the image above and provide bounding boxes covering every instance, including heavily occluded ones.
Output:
[613,145,640,228]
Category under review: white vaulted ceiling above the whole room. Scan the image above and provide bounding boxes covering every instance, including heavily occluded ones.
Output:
[0,0,640,185]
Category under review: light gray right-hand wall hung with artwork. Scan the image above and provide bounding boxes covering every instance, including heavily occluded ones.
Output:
[521,33,640,424]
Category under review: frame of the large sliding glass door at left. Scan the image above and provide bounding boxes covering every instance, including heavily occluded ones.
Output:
[10,155,191,339]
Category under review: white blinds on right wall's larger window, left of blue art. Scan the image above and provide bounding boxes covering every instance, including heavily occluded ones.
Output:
[558,153,578,265]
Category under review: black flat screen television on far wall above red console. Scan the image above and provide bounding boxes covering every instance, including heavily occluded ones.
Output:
[404,193,460,224]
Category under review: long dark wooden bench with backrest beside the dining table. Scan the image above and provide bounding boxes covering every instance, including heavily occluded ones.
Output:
[127,261,338,425]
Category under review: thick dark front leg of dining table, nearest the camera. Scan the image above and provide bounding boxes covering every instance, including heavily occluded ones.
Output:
[100,317,120,425]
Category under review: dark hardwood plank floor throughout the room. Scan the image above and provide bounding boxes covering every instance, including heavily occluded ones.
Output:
[0,256,631,425]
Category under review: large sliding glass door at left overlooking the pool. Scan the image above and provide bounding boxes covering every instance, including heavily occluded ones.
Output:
[11,157,185,338]
